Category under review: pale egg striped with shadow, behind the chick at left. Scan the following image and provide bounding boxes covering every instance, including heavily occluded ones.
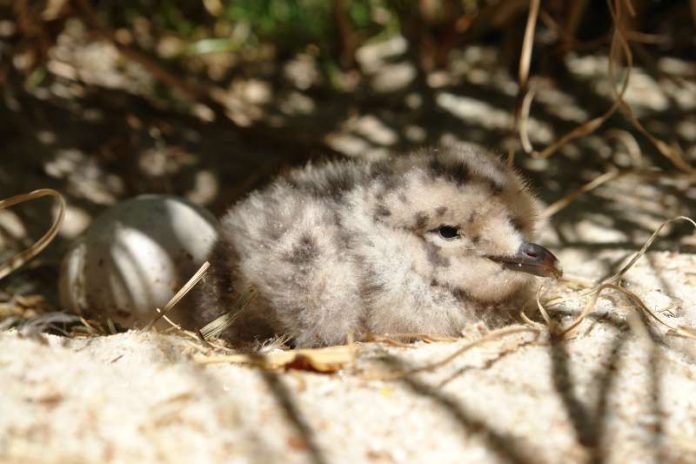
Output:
[59,195,218,328]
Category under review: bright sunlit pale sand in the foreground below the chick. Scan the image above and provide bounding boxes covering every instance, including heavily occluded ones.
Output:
[0,248,696,463]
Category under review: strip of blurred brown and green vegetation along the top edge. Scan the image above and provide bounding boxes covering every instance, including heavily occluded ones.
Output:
[0,0,696,99]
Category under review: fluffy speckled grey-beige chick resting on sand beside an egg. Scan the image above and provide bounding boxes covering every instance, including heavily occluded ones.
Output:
[195,145,560,346]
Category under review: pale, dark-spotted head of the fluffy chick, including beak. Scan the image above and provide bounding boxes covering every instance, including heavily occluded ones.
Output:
[369,146,561,303]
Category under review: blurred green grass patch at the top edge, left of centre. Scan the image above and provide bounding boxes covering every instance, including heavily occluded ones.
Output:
[100,0,386,55]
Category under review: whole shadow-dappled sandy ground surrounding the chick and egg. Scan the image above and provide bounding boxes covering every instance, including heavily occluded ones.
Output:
[0,15,696,463]
